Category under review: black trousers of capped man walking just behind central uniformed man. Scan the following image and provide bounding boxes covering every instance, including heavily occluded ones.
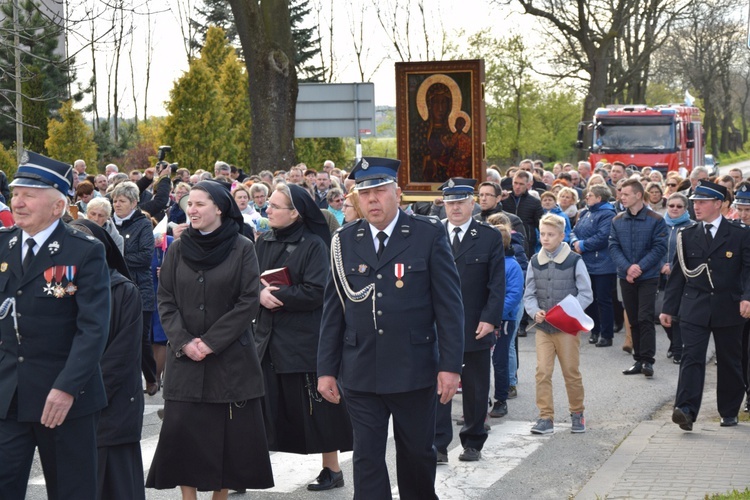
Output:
[435,348,493,453]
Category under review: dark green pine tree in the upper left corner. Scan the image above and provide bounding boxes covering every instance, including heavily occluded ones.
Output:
[0,0,81,148]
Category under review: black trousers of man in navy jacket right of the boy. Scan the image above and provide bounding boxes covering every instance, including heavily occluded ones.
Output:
[620,278,660,364]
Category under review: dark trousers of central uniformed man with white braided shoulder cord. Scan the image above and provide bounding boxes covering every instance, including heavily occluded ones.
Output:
[346,386,440,500]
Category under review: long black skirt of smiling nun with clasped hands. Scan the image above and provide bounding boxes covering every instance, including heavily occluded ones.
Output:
[146,398,273,491]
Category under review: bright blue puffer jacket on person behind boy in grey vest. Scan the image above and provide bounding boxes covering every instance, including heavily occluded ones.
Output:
[570,201,617,275]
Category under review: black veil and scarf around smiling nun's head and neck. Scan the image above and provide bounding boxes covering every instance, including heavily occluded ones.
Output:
[180,180,245,271]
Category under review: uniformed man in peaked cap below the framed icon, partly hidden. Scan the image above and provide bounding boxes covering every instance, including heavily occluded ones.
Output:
[435,178,508,463]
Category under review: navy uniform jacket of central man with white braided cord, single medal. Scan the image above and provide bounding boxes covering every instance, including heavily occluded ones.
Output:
[318,211,464,394]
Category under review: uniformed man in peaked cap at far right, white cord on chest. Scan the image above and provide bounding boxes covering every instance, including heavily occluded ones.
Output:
[659,181,750,431]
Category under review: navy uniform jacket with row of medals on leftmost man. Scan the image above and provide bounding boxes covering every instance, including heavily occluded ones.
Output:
[0,221,110,422]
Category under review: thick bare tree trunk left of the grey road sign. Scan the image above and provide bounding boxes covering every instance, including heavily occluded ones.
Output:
[229,0,298,172]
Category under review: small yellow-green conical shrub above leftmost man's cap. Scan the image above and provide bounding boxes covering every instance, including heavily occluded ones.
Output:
[45,100,96,165]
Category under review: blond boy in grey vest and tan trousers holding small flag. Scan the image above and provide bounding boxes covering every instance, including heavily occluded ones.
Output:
[523,214,593,434]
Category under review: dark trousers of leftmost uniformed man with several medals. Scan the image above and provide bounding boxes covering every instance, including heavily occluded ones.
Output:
[0,402,99,500]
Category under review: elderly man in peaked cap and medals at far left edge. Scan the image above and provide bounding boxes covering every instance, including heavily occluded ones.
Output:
[0,152,110,500]
